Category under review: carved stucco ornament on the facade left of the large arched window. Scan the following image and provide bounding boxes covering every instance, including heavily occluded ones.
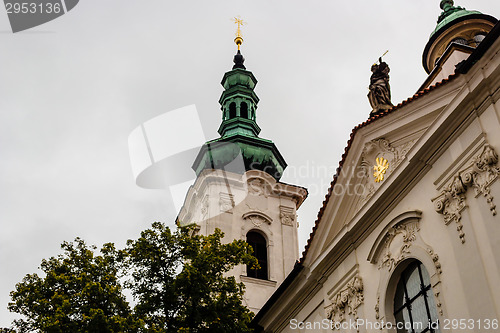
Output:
[325,276,364,322]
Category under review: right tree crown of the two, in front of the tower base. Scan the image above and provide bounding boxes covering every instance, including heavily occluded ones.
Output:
[127,222,257,333]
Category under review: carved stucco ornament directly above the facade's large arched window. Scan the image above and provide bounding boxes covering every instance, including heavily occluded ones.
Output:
[378,221,420,271]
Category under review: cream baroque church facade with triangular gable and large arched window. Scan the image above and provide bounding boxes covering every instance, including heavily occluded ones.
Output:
[253,1,500,332]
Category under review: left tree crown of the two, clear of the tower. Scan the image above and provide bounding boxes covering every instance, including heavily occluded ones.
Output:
[5,238,140,333]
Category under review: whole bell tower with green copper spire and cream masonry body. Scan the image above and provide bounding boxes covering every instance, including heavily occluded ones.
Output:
[178,19,307,312]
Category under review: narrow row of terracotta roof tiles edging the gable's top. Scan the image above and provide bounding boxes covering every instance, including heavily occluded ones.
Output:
[299,74,458,264]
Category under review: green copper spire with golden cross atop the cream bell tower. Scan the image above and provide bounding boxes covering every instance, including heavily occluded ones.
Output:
[189,35,287,180]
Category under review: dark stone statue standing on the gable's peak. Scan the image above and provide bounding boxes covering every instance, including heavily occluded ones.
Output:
[368,58,393,115]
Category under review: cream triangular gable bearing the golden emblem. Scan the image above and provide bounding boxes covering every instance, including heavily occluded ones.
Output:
[305,80,460,262]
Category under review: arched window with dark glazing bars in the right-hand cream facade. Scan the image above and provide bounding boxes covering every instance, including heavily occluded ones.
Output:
[394,261,439,333]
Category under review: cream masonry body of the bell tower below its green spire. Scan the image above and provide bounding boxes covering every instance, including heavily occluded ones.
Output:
[178,170,307,312]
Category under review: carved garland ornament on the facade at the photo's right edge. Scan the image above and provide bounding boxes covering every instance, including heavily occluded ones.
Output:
[432,144,500,244]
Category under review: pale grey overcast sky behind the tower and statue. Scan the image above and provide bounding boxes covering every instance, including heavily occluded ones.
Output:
[0,0,500,327]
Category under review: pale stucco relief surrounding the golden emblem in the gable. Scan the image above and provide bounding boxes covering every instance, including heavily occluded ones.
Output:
[357,139,416,209]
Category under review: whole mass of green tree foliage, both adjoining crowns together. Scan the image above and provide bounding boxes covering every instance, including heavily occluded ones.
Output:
[4,222,258,333]
